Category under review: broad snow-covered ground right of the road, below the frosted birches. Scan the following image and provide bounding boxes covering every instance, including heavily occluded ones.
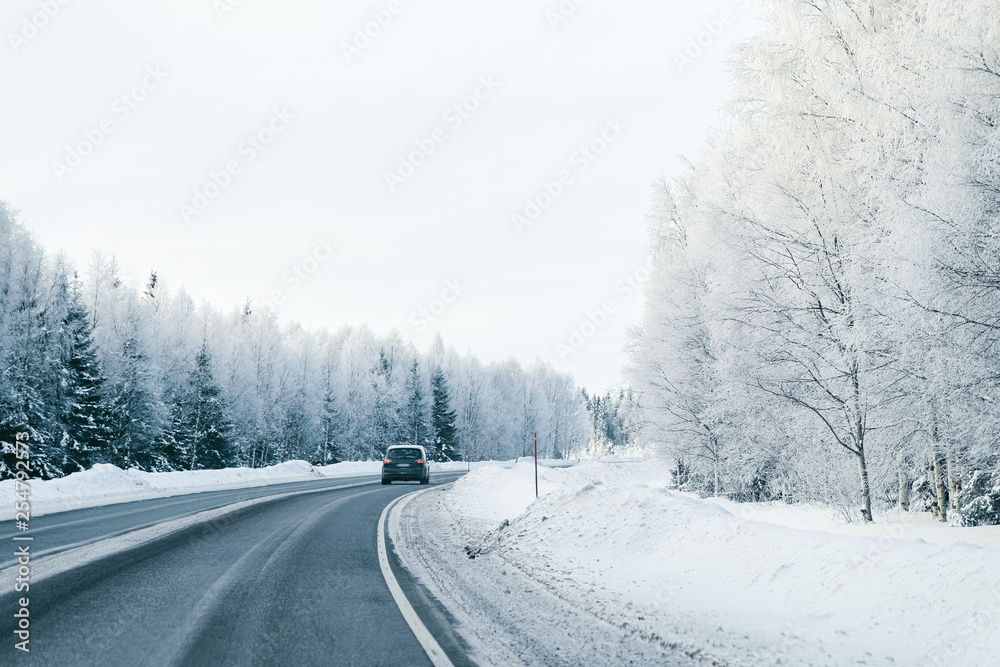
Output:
[390,461,1000,666]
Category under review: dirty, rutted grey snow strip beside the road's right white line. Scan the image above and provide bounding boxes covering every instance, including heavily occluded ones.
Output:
[387,486,700,667]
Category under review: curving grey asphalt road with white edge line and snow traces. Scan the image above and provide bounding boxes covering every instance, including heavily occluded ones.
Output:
[0,473,468,666]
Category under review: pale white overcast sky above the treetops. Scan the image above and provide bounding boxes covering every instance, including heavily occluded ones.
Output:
[0,0,757,389]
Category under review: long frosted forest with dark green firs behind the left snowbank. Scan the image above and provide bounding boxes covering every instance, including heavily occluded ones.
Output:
[0,202,590,479]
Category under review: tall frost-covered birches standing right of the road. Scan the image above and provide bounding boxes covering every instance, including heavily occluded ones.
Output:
[626,0,1000,525]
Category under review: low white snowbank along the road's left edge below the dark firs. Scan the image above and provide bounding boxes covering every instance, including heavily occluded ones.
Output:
[0,461,500,520]
